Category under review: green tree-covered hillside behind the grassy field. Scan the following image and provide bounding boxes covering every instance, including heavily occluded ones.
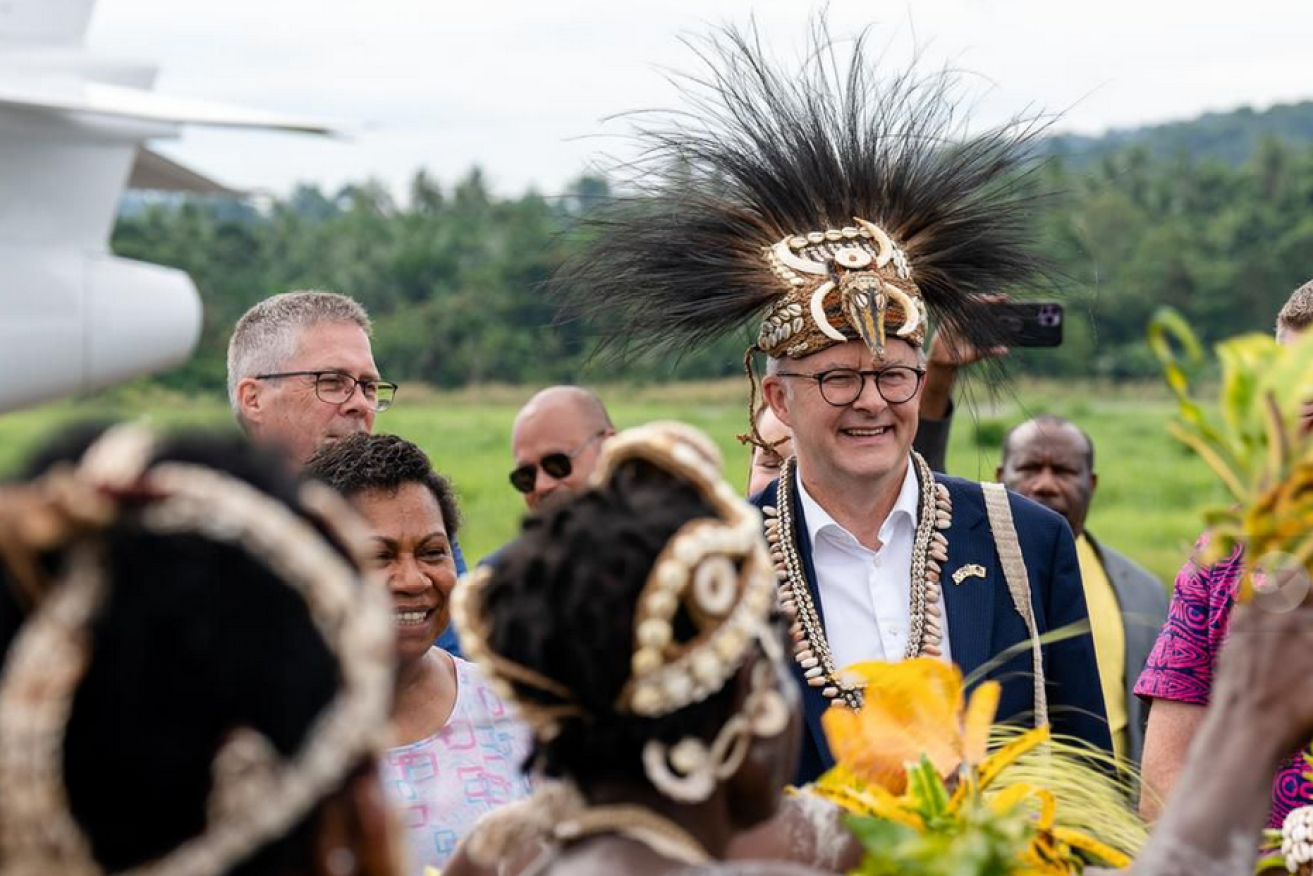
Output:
[113,102,1313,389]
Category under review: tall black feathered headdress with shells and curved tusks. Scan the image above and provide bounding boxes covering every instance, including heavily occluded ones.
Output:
[559,20,1041,438]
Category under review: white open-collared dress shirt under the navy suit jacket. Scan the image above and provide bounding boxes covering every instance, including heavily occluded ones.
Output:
[798,462,952,668]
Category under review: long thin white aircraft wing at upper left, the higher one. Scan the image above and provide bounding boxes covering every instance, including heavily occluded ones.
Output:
[0,81,334,134]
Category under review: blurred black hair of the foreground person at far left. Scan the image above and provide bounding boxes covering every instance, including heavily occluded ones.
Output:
[0,428,370,876]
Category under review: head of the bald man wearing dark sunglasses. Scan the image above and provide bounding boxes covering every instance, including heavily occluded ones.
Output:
[509,386,616,510]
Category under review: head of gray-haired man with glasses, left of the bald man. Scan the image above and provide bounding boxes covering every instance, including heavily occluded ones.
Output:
[228,292,397,469]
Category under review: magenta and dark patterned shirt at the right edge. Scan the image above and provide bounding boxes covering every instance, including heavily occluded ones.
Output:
[1136,533,1313,827]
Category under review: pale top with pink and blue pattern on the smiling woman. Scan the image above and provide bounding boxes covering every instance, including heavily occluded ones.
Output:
[379,657,532,876]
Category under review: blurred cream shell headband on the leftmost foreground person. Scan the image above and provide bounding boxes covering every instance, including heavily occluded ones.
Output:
[0,426,394,876]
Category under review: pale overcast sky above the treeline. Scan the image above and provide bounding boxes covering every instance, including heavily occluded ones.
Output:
[88,0,1313,194]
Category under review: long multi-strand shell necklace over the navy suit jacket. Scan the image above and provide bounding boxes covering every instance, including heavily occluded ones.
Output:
[762,452,953,709]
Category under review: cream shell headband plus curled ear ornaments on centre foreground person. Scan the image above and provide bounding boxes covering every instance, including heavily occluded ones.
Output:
[452,423,789,802]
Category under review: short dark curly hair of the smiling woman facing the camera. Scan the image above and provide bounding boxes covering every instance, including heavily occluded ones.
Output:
[301,432,461,538]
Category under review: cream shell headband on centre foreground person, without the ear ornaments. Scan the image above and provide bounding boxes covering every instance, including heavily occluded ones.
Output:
[452,423,775,737]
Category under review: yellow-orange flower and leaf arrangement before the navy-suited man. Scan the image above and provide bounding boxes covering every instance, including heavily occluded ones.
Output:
[811,658,1146,876]
